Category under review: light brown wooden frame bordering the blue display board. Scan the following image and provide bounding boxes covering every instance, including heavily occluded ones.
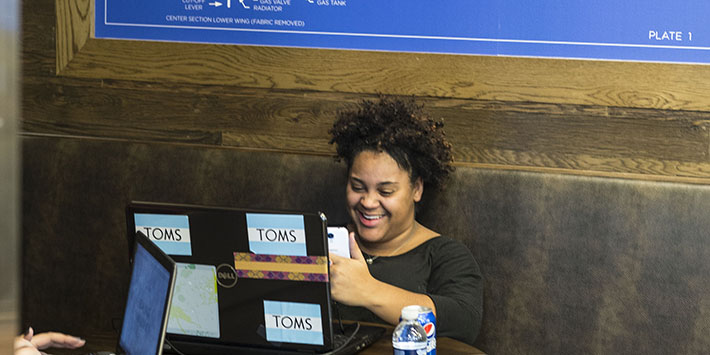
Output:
[57,0,710,111]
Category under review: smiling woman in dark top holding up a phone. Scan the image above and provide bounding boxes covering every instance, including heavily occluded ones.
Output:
[330,97,482,344]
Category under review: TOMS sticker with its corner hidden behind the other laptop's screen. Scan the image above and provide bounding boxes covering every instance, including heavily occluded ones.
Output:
[133,213,192,256]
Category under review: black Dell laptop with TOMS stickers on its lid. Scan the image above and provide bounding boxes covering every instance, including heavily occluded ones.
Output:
[126,202,386,355]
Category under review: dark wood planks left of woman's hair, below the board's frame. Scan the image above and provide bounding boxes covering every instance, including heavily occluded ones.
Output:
[24,81,364,147]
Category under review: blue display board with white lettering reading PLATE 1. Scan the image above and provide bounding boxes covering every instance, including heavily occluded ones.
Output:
[95,0,710,63]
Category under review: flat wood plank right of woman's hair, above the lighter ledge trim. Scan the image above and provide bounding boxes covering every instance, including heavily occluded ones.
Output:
[436,103,710,161]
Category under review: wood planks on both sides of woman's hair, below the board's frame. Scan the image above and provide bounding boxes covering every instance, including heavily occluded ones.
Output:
[23,78,710,179]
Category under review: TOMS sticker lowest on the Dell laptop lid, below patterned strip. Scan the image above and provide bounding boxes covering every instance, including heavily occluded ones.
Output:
[264,300,323,345]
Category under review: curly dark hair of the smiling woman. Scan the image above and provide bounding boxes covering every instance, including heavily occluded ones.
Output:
[329,96,454,188]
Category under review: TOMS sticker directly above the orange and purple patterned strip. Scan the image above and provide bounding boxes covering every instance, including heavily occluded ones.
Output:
[247,213,307,256]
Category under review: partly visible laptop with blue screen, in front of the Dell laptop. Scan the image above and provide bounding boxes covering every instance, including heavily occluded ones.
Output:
[97,232,177,355]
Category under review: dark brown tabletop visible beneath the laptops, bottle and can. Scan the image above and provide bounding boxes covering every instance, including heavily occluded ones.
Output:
[48,329,485,355]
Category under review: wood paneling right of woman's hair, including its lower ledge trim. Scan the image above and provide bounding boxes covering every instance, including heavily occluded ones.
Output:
[430,100,710,183]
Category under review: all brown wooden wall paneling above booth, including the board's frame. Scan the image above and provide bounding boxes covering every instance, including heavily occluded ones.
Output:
[22,0,710,183]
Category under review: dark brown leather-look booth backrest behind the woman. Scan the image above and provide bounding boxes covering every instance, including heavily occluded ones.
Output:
[22,137,710,354]
